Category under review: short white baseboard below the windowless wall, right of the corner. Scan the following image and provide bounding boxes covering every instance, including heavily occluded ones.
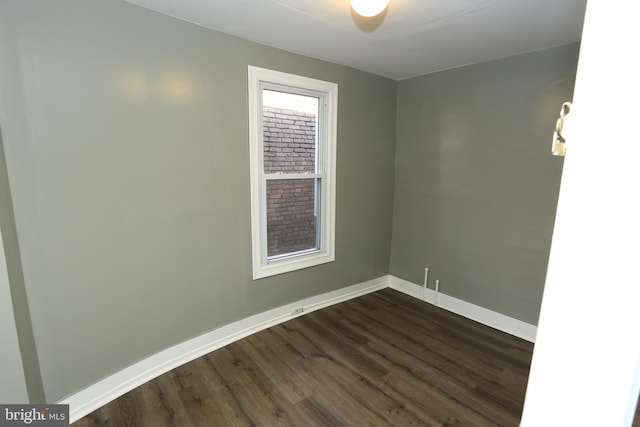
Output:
[388,275,537,342]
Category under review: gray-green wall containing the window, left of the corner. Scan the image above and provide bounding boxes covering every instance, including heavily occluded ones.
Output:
[0,0,396,401]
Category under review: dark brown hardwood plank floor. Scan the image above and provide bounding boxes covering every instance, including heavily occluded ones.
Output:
[73,289,640,427]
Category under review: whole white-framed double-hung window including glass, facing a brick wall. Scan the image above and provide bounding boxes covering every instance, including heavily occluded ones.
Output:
[249,66,338,279]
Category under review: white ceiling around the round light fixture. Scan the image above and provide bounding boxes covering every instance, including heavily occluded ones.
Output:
[127,0,586,80]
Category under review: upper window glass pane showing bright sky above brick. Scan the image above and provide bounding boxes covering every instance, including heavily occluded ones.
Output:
[262,89,318,173]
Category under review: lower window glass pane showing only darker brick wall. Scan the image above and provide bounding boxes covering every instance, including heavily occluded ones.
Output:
[267,178,320,257]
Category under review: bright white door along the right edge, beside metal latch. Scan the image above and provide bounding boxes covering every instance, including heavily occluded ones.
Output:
[521,0,640,427]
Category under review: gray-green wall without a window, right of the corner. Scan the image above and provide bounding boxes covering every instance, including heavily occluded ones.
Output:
[390,45,578,324]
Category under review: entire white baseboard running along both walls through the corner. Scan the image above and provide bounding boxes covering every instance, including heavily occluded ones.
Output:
[63,275,536,423]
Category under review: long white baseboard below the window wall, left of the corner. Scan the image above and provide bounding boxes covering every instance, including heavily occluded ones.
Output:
[57,276,389,423]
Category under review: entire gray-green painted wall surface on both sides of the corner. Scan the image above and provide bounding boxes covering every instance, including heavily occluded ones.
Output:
[0,0,577,402]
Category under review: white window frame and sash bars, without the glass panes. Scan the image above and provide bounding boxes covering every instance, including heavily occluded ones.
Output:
[248,65,338,280]
